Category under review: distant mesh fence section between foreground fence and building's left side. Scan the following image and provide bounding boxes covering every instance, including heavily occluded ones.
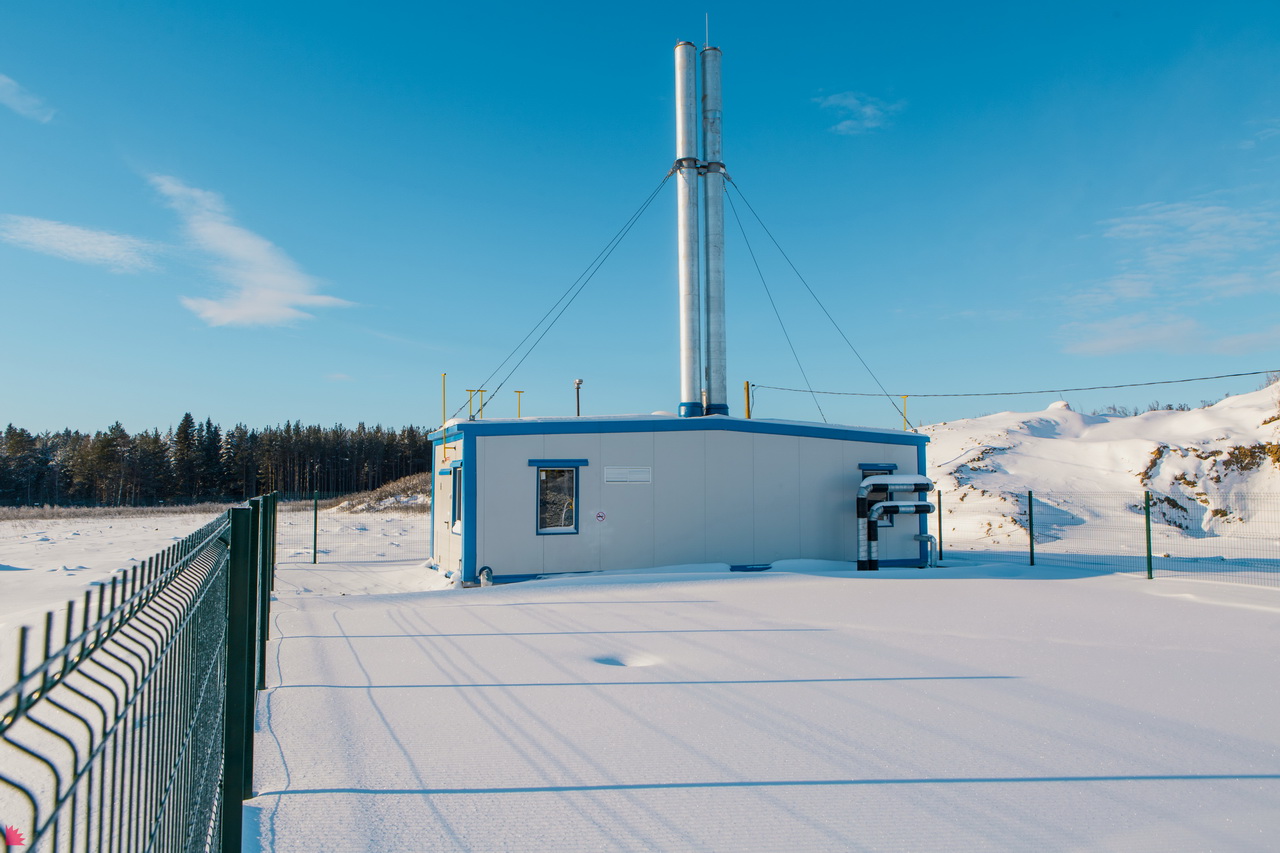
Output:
[276,494,431,562]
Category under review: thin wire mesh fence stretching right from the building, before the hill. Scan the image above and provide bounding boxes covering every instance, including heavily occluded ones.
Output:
[931,488,1280,587]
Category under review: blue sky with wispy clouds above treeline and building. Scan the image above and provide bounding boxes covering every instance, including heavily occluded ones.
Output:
[0,0,1280,430]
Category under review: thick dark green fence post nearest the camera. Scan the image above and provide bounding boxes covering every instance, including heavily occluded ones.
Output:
[221,506,253,853]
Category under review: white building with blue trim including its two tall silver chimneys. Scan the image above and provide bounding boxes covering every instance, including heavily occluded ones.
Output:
[431,41,932,583]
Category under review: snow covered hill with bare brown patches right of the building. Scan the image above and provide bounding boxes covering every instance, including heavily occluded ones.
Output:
[920,384,1280,546]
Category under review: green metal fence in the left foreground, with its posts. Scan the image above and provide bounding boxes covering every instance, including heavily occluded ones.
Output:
[0,496,275,853]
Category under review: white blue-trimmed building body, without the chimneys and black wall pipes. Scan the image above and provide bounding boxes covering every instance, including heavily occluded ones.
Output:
[431,415,928,583]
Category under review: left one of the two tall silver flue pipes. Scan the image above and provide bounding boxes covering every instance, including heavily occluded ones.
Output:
[676,41,703,418]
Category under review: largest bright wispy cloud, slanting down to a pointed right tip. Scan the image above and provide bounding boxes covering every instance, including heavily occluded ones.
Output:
[151,175,351,325]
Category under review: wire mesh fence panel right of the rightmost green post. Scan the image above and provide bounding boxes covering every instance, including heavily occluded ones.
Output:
[1151,492,1280,587]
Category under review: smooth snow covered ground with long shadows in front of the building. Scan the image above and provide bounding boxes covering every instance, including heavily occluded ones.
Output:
[246,558,1280,853]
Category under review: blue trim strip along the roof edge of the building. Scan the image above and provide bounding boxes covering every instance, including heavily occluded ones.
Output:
[431,416,929,445]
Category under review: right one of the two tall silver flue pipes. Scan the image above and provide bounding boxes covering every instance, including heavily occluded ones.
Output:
[703,47,728,415]
